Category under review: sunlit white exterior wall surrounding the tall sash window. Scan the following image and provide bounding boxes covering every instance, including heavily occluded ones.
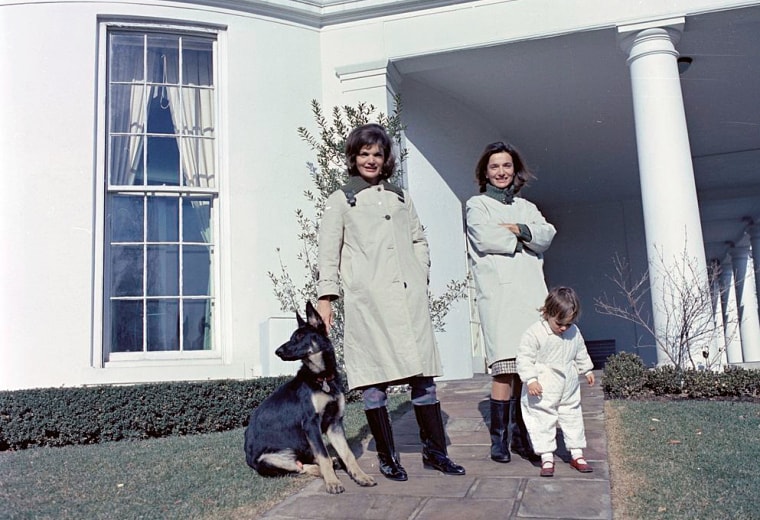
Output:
[0,2,321,389]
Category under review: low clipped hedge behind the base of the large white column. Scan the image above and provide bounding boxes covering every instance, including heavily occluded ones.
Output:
[602,352,760,399]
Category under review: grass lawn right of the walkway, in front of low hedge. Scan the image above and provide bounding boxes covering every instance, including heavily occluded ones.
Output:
[605,401,760,520]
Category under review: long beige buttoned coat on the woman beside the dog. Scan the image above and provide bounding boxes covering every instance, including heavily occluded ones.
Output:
[317,184,441,388]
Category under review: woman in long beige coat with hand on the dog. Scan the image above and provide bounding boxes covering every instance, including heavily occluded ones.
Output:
[317,124,465,481]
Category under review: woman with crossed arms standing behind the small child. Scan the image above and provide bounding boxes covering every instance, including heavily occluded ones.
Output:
[466,142,556,462]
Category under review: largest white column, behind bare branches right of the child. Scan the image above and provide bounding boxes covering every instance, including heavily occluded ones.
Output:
[618,18,712,365]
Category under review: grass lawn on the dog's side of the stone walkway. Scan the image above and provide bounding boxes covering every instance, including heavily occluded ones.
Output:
[0,394,411,520]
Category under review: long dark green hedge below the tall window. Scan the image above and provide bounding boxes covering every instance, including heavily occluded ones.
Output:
[0,376,296,451]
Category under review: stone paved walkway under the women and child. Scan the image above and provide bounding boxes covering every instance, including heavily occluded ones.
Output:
[262,372,612,520]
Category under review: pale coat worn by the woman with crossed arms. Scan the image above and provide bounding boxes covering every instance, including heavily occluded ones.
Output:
[467,195,557,365]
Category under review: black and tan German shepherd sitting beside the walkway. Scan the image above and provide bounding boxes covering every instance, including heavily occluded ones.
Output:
[245,302,376,493]
